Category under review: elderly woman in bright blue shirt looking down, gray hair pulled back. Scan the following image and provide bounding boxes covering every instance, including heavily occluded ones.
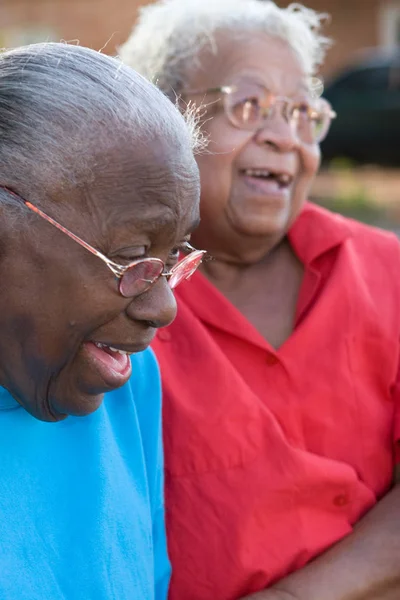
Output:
[0,44,202,600]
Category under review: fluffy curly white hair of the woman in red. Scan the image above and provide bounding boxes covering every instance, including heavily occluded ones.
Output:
[119,0,330,97]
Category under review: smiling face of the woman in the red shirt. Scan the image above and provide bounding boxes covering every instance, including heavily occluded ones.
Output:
[185,34,320,263]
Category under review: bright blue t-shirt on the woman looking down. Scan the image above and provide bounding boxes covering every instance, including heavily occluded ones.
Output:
[0,350,170,600]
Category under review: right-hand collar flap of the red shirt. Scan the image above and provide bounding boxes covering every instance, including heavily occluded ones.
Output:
[288,203,352,265]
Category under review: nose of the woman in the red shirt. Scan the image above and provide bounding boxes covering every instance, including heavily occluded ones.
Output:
[255,106,299,152]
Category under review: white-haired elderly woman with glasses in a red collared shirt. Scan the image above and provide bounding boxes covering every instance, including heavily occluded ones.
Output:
[121,0,400,600]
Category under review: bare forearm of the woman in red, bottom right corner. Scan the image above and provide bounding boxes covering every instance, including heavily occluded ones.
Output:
[243,468,400,600]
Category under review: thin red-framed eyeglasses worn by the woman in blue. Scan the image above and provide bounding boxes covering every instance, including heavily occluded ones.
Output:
[0,186,206,298]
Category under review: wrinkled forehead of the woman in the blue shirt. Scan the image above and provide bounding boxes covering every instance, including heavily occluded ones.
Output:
[74,136,199,241]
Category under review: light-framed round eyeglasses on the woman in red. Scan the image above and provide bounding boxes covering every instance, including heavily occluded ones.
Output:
[185,80,336,144]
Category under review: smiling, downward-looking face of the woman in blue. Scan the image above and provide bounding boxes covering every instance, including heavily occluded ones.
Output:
[0,139,199,421]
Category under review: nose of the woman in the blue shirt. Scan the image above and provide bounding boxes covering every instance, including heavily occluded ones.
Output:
[126,277,177,327]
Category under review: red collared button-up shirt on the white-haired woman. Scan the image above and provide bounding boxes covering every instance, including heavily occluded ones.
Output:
[154,205,400,600]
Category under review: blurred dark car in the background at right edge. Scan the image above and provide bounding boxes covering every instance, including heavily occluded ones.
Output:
[321,49,400,167]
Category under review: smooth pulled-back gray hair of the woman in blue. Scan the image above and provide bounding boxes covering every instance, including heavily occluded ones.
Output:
[0,43,197,206]
